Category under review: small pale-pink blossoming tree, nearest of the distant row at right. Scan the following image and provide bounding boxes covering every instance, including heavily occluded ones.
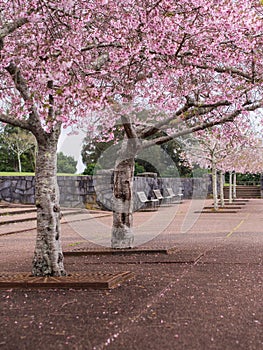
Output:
[177,118,255,211]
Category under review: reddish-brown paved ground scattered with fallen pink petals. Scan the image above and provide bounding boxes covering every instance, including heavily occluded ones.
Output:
[0,200,263,350]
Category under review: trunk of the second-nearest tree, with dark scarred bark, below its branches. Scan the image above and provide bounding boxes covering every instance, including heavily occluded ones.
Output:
[111,140,136,249]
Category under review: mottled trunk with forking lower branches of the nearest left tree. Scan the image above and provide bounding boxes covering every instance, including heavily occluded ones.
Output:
[0,62,66,276]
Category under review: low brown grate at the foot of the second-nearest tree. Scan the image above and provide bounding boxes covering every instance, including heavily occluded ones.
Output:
[63,248,174,256]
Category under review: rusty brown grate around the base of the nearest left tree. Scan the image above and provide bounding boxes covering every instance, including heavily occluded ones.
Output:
[0,271,134,289]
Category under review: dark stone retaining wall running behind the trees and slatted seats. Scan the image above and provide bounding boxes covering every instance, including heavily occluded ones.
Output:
[0,175,211,209]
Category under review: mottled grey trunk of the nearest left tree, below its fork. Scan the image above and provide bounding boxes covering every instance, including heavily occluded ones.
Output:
[32,132,66,276]
